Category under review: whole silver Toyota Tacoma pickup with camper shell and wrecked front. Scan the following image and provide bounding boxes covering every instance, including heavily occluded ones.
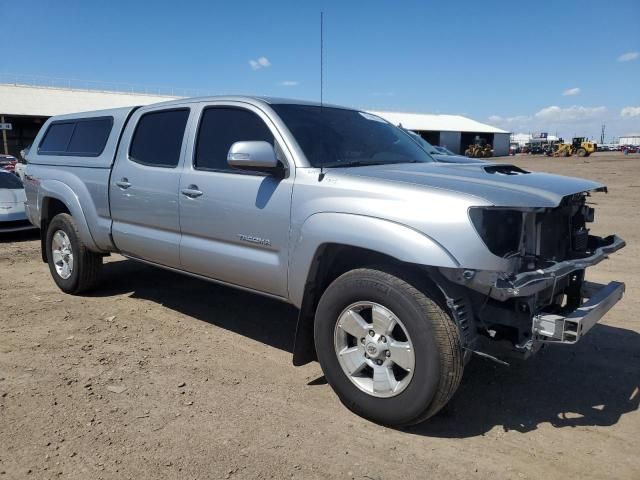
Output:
[25,97,624,425]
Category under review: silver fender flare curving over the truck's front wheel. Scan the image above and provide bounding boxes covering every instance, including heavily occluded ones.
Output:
[288,213,460,308]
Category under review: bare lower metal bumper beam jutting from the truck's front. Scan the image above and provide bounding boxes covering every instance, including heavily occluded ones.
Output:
[532,282,625,344]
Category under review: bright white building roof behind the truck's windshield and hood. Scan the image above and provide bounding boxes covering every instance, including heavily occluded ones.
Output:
[369,110,509,133]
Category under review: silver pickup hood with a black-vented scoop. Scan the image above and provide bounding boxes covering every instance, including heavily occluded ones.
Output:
[339,162,606,208]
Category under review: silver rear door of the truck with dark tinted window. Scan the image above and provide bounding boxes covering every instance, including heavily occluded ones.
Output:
[109,106,190,268]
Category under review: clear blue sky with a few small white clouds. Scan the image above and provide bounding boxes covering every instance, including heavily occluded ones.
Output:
[0,0,640,138]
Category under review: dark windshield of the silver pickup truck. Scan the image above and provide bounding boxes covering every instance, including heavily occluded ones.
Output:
[272,104,433,167]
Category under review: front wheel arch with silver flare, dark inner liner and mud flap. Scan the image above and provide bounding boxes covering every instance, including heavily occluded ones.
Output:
[289,213,459,365]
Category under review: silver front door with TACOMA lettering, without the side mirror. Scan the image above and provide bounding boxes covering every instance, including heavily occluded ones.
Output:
[180,103,293,297]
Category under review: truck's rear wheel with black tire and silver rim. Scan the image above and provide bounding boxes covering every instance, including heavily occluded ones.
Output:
[45,213,102,294]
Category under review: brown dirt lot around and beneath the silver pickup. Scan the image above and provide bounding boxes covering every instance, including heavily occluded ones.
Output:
[0,154,640,480]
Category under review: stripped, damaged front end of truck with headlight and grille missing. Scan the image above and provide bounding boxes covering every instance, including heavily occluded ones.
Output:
[440,188,625,356]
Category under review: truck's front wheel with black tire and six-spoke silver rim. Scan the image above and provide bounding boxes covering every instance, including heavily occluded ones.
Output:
[314,269,464,426]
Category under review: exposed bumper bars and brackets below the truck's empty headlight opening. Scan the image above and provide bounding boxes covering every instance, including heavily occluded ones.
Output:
[440,235,625,356]
